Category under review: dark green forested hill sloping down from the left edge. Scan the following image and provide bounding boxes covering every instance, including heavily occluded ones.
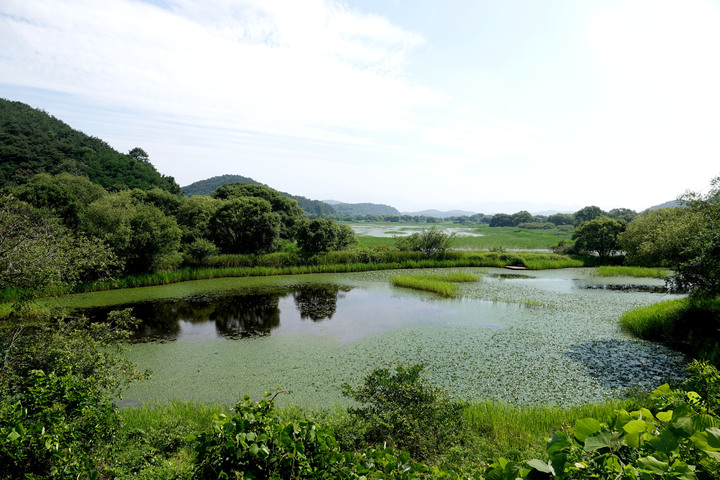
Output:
[0,98,180,193]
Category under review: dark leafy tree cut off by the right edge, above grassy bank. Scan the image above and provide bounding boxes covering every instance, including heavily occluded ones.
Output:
[672,177,720,298]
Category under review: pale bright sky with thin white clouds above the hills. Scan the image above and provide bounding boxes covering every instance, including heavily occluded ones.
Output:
[0,0,720,214]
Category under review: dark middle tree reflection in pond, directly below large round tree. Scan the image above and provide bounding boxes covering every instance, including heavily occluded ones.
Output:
[213,293,280,337]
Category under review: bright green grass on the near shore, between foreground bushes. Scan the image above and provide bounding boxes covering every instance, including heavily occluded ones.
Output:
[103,400,635,479]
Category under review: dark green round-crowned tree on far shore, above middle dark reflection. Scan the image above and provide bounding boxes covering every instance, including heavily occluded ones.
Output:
[208,197,280,253]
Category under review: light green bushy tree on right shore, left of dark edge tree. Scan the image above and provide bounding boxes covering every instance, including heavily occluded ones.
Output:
[618,208,700,267]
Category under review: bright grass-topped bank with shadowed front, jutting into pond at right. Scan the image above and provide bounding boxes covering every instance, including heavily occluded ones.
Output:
[620,297,720,366]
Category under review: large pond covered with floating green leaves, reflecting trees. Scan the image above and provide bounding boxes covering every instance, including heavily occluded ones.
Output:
[64,269,686,407]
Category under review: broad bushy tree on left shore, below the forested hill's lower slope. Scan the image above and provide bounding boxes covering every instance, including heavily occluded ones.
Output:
[84,191,181,273]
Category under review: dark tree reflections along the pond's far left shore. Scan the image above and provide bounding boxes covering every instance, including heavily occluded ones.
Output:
[79,285,351,341]
